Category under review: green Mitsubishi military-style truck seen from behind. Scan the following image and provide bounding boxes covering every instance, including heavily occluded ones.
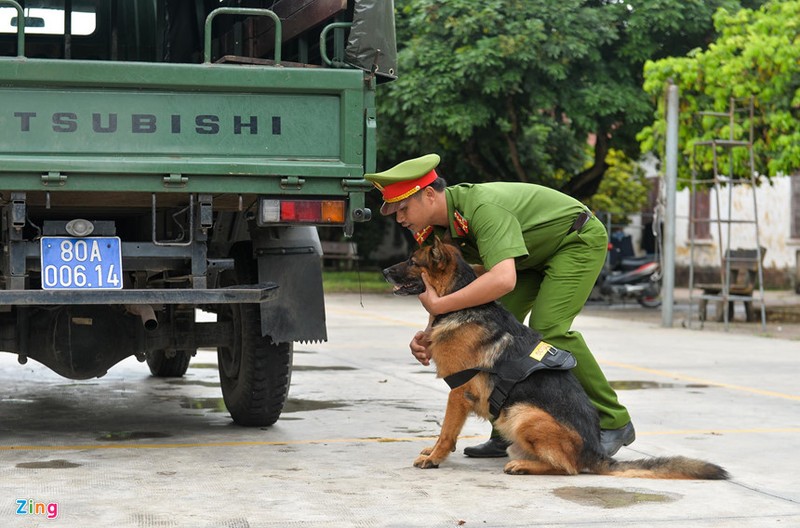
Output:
[0,0,396,426]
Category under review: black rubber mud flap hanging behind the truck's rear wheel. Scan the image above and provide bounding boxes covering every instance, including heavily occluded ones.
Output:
[258,252,328,343]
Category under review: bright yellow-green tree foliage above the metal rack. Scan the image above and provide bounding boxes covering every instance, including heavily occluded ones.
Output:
[640,0,800,184]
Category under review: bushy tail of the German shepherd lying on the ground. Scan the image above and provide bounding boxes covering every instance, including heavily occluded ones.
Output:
[592,456,730,480]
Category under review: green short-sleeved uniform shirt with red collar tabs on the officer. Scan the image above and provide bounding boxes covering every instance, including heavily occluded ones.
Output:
[445,182,586,270]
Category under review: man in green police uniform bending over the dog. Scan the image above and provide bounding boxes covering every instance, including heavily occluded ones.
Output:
[364,154,636,457]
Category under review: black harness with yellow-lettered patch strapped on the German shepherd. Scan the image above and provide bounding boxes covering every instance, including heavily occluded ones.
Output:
[444,341,578,418]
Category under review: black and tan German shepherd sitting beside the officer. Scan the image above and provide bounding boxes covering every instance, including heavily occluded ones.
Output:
[383,238,728,480]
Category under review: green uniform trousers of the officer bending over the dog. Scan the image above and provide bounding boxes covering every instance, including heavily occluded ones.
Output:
[493,218,631,435]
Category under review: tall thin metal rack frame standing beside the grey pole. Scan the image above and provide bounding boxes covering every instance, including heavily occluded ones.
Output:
[689,98,766,330]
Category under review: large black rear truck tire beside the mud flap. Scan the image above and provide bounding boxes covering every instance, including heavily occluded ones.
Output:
[217,304,293,427]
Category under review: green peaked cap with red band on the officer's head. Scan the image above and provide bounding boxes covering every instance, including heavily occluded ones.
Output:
[364,154,439,216]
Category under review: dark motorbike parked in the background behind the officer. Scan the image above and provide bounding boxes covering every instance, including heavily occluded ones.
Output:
[589,235,661,308]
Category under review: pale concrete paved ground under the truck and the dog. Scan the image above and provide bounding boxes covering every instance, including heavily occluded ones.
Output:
[0,295,800,528]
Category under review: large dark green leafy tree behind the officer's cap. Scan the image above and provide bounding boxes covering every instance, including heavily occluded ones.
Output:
[378,0,760,198]
